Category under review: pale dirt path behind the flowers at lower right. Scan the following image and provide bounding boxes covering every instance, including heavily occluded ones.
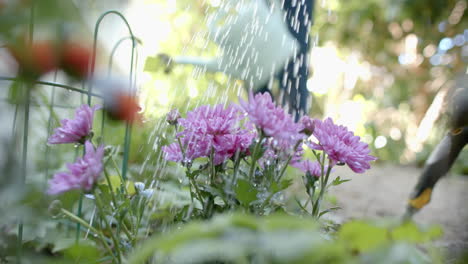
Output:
[331,166,468,258]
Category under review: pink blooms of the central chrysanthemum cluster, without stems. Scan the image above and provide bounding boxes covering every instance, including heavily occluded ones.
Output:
[163,92,376,176]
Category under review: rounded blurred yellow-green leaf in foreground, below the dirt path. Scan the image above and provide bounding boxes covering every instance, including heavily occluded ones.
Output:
[338,221,388,252]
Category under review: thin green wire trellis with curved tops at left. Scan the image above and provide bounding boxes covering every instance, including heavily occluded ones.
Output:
[0,6,141,263]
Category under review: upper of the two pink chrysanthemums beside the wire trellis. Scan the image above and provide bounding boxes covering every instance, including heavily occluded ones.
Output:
[47,104,100,144]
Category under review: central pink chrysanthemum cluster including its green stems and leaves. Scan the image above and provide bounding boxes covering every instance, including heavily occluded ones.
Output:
[159,92,376,218]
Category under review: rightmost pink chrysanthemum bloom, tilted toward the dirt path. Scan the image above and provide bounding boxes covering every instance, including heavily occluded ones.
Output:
[308,118,377,173]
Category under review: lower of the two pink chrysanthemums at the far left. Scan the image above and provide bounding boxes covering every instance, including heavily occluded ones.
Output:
[47,141,104,195]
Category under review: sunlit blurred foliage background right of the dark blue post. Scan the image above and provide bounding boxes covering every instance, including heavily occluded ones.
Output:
[311,0,468,173]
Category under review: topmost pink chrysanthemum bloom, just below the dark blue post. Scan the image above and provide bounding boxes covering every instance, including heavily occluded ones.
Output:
[239,91,303,144]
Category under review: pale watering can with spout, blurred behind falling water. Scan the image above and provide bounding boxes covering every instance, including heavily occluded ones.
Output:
[159,0,299,90]
